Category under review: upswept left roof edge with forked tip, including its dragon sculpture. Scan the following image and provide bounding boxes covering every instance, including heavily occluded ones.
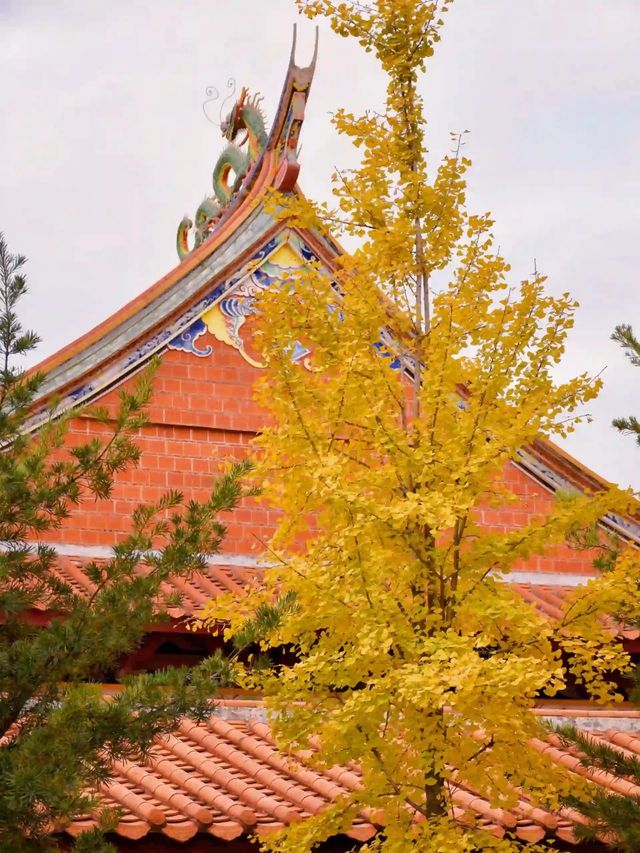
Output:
[31,26,320,422]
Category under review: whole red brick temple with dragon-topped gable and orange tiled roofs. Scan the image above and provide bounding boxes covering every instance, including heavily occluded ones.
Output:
[27,33,640,853]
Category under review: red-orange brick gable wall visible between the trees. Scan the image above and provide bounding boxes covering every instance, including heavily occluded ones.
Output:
[46,335,591,573]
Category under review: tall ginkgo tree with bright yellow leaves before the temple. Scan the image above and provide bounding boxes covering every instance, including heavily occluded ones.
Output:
[203,0,638,853]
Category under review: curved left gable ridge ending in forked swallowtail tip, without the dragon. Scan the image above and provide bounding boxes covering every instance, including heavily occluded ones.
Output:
[28,28,317,427]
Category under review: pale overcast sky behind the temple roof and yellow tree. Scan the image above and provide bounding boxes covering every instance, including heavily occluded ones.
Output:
[0,0,640,486]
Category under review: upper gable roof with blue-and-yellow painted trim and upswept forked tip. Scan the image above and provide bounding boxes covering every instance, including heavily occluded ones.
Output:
[17,30,640,542]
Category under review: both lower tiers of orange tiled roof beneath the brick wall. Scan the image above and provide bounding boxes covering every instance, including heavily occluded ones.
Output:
[23,546,640,849]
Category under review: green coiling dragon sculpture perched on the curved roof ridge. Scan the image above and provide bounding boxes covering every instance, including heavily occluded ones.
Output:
[176,88,267,260]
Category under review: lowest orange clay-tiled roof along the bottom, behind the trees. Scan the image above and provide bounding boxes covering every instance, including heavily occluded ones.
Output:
[56,699,640,844]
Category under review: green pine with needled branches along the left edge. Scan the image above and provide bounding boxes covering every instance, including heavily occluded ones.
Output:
[0,235,251,853]
